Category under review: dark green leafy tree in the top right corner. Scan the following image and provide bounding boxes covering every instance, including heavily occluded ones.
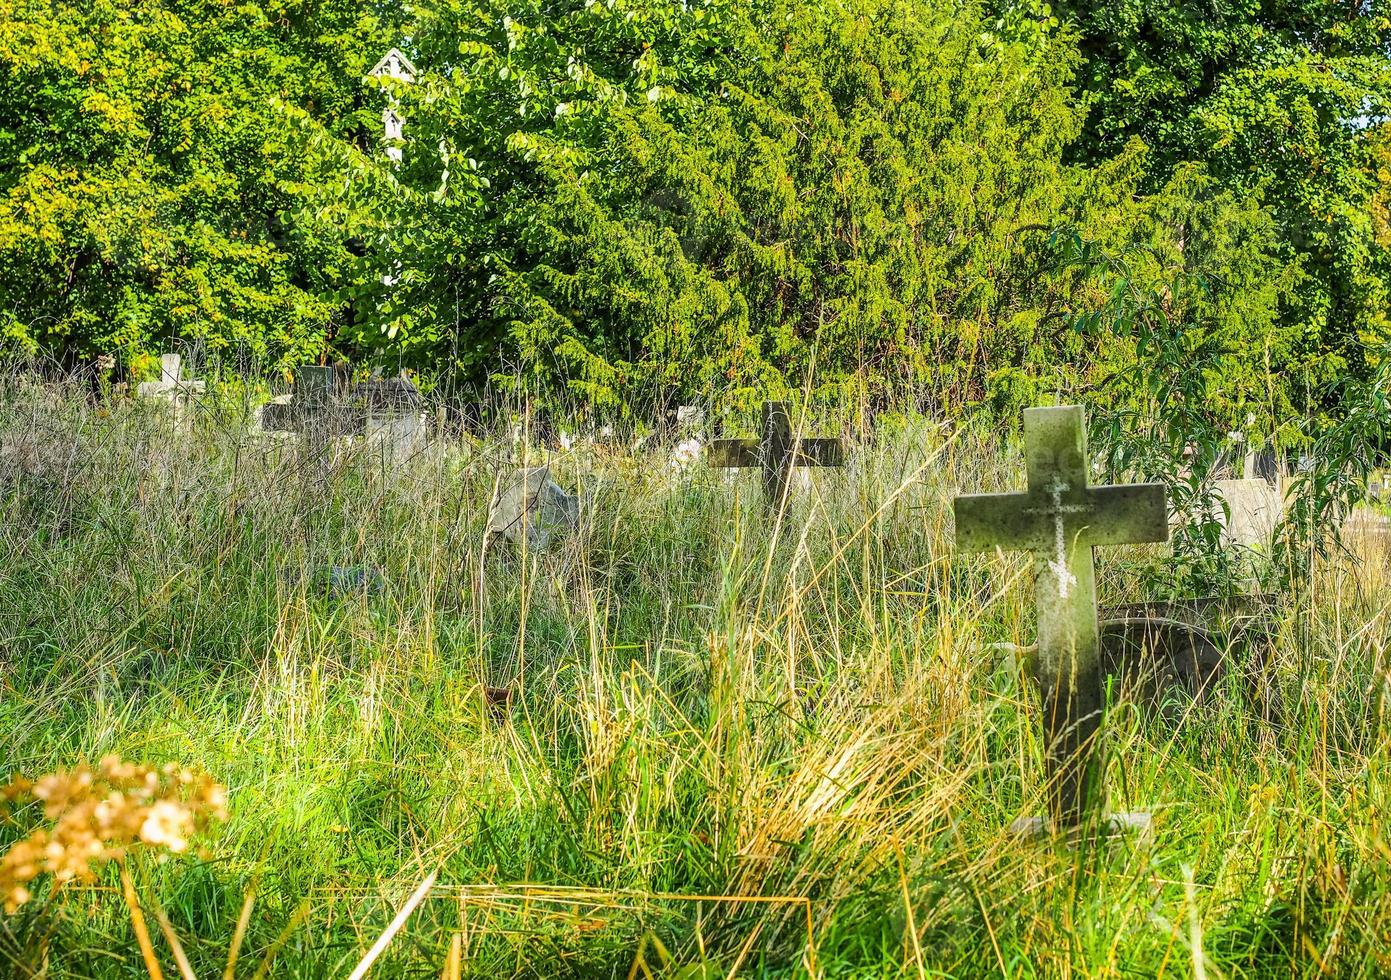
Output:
[1051,0,1391,397]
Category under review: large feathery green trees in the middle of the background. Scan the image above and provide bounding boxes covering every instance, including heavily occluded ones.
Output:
[325,0,1285,407]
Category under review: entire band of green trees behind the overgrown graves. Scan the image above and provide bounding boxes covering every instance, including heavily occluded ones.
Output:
[0,0,1391,417]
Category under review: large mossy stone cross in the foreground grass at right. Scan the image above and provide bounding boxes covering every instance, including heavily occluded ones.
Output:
[956,405,1168,827]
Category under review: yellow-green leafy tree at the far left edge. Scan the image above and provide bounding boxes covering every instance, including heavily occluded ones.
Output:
[0,0,394,363]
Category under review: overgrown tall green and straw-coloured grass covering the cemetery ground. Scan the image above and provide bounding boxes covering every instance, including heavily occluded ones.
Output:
[0,378,1391,977]
